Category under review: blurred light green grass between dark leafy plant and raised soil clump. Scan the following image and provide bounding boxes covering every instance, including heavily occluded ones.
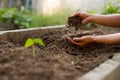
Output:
[31,9,72,27]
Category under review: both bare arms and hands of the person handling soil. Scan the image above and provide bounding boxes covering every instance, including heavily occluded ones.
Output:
[67,13,120,47]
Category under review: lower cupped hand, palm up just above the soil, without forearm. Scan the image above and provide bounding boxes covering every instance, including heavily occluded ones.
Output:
[67,36,95,47]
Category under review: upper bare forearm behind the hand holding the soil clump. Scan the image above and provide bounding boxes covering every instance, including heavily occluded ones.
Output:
[91,14,120,27]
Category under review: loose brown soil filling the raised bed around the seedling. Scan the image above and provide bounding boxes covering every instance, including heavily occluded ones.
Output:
[0,28,120,80]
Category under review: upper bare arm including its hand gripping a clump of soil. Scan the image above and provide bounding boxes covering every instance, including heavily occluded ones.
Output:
[73,12,120,27]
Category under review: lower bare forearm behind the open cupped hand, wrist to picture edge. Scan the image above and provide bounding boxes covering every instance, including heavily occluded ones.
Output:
[94,33,120,44]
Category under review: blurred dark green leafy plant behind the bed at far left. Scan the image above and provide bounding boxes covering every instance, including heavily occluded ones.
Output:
[0,8,32,29]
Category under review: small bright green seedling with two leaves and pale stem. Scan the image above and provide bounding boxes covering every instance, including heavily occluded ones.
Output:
[24,38,45,57]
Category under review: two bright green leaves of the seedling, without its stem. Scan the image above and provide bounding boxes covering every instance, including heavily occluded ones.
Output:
[25,38,45,48]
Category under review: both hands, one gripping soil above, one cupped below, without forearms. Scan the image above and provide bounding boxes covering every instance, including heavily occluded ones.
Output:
[67,13,95,47]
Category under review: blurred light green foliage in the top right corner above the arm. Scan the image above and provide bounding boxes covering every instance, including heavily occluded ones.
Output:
[102,2,120,14]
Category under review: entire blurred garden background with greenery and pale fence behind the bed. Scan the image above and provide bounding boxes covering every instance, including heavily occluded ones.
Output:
[0,0,120,30]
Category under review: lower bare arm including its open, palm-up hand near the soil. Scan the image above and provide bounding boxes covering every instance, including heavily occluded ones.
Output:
[67,33,120,47]
